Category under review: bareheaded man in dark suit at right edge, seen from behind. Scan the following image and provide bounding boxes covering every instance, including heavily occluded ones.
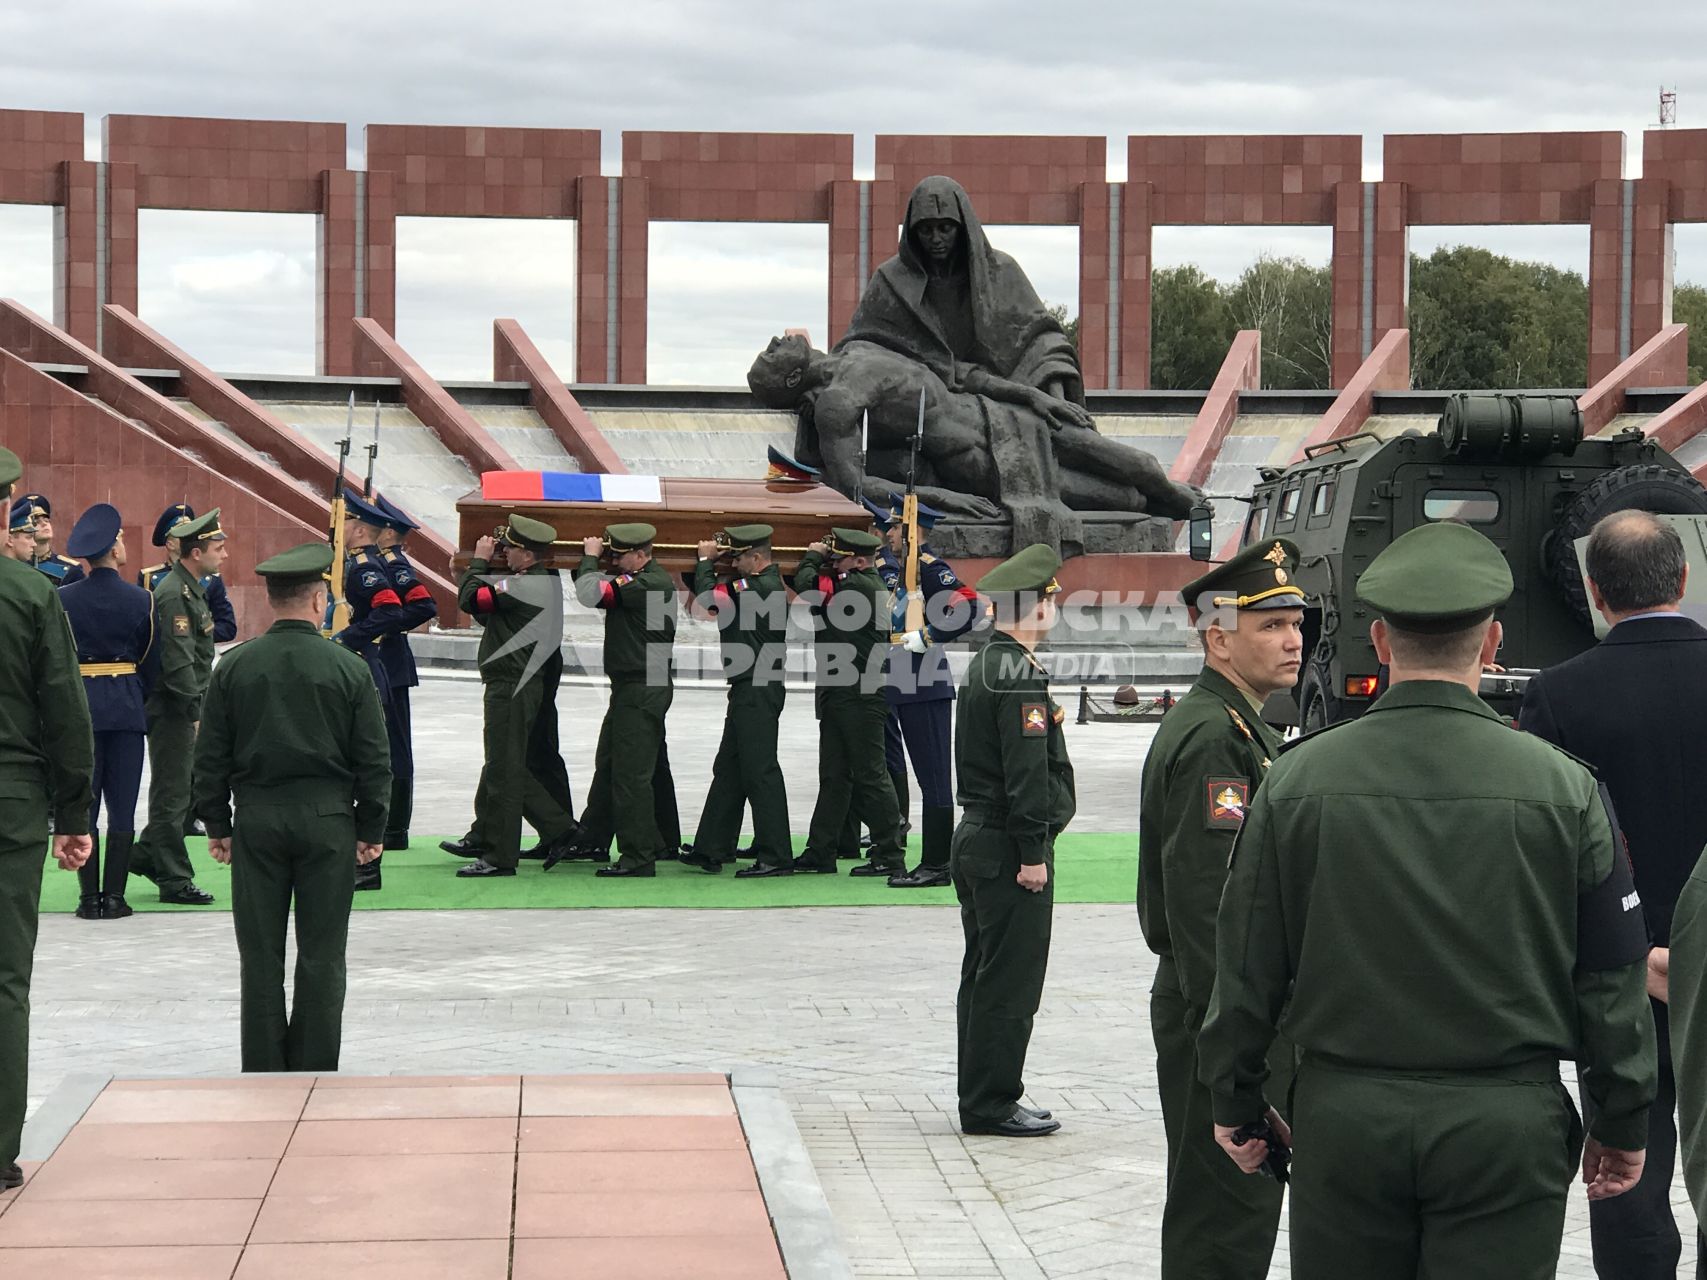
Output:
[1518,510,1707,1280]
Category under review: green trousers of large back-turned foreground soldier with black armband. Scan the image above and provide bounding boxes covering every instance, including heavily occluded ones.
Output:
[1287,1053,1582,1280]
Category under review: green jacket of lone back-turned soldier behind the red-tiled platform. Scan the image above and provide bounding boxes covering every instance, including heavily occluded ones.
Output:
[195,620,391,845]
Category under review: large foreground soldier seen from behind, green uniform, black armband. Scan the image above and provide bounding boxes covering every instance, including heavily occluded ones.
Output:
[1197,524,1657,1280]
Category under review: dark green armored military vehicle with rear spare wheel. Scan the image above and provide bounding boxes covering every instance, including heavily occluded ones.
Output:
[1193,393,1707,730]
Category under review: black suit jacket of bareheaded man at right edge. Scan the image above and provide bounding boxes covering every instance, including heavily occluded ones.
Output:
[1518,614,1707,947]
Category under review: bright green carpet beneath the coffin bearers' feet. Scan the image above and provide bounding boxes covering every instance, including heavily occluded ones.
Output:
[41,831,1137,913]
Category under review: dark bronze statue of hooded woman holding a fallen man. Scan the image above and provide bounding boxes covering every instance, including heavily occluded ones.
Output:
[748,177,1197,548]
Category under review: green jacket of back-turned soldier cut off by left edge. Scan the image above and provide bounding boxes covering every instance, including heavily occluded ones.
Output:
[0,558,96,836]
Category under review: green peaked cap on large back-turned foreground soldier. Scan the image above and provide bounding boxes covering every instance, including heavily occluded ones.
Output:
[1357,522,1512,635]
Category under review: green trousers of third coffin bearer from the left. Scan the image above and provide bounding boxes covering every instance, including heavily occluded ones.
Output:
[693,681,794,867]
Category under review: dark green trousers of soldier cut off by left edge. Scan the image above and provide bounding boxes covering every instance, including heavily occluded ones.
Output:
[0,802,48,1166]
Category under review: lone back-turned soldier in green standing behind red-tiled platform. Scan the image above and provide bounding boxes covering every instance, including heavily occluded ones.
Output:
[196,541,391,1072]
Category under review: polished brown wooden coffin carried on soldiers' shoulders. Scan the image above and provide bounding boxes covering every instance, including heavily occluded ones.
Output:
[452,476,872,573]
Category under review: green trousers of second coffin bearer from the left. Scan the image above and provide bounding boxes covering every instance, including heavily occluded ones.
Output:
[580,679,676,867]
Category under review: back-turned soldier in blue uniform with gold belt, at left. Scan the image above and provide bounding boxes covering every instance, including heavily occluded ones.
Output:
[60,502,159,920]
